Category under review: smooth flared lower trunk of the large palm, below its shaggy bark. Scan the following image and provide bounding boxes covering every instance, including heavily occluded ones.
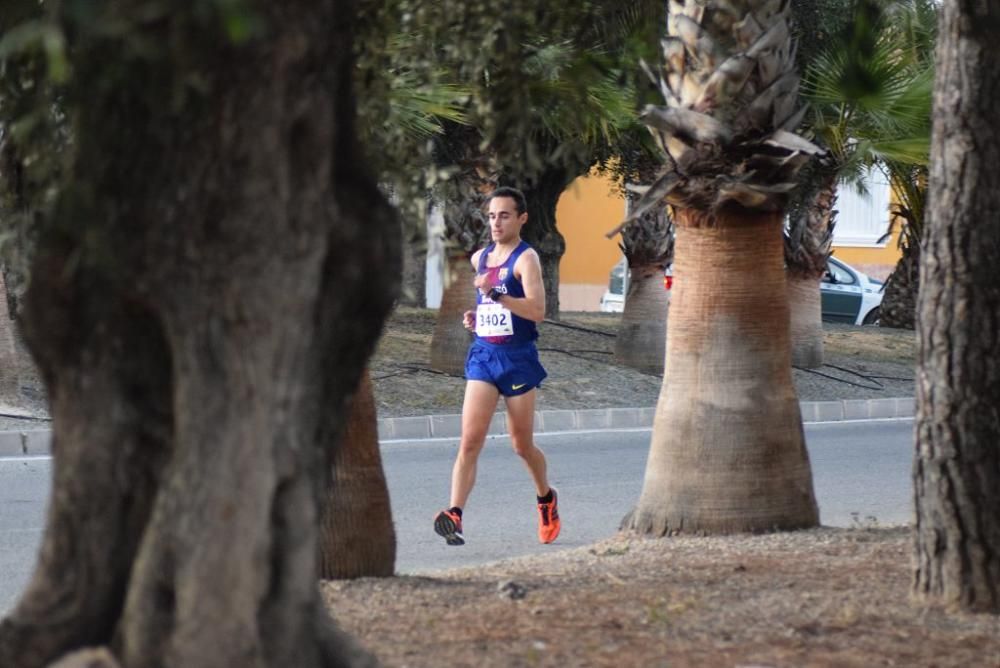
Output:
[622,210,819,535]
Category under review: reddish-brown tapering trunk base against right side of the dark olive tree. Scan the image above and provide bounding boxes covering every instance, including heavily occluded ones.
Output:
[319,370,396,580]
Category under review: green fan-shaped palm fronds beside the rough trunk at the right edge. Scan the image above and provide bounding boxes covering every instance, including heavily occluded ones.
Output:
[788,0,937,264]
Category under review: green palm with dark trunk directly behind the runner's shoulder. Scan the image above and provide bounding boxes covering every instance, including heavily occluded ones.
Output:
[434,0,662,318]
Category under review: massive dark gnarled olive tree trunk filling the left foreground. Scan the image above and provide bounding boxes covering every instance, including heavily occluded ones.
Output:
[0,0,399,668]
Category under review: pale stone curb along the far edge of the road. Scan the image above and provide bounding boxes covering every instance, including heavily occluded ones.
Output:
[0,397,916,458]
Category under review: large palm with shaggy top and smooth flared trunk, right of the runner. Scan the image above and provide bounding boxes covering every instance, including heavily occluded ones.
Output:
[622,0,820,535]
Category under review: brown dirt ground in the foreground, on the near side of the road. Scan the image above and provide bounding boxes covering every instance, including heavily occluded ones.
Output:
[322,526,1000,668]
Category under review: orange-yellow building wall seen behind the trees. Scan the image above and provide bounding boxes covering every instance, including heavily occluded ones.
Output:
[560,174,900,311]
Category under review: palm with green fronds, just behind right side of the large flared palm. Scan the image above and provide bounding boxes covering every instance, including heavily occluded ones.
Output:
[785,0,933,354]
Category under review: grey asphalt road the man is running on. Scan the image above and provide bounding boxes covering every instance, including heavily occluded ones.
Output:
[0,419,913,614]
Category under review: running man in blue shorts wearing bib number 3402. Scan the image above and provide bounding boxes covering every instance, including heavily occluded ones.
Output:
[434,188,560,545]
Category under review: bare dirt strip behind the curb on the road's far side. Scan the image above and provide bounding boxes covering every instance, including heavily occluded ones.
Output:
[371,307,915,417]
